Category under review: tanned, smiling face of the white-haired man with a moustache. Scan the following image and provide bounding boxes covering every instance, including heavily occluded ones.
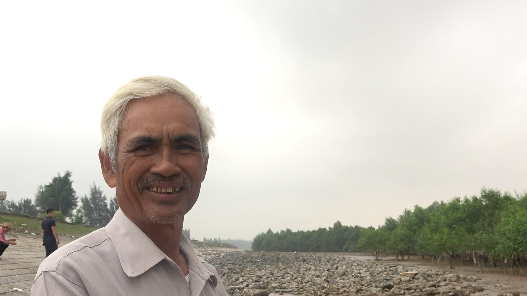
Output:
[101,95,207,226]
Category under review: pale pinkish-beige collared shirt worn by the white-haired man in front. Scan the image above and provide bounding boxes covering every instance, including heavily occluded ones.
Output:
[31,209,227,296]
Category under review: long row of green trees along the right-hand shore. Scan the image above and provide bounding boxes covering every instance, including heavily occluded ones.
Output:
[253,188,527,269]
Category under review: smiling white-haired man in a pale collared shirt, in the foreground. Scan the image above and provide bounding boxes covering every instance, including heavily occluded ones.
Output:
[31,76,227,296]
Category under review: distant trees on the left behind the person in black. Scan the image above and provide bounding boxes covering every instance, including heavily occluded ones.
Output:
[0,171,119,227]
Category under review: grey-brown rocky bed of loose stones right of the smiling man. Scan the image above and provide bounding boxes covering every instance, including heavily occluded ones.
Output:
[198,250,527,295]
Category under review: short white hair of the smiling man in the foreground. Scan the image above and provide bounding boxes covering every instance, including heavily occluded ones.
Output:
[101,76,214,170]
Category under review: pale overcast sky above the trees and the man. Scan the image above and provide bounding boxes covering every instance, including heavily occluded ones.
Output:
[0,0,527,239]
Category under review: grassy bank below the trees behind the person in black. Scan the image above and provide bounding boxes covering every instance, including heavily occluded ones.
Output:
[0,213,97,237]
